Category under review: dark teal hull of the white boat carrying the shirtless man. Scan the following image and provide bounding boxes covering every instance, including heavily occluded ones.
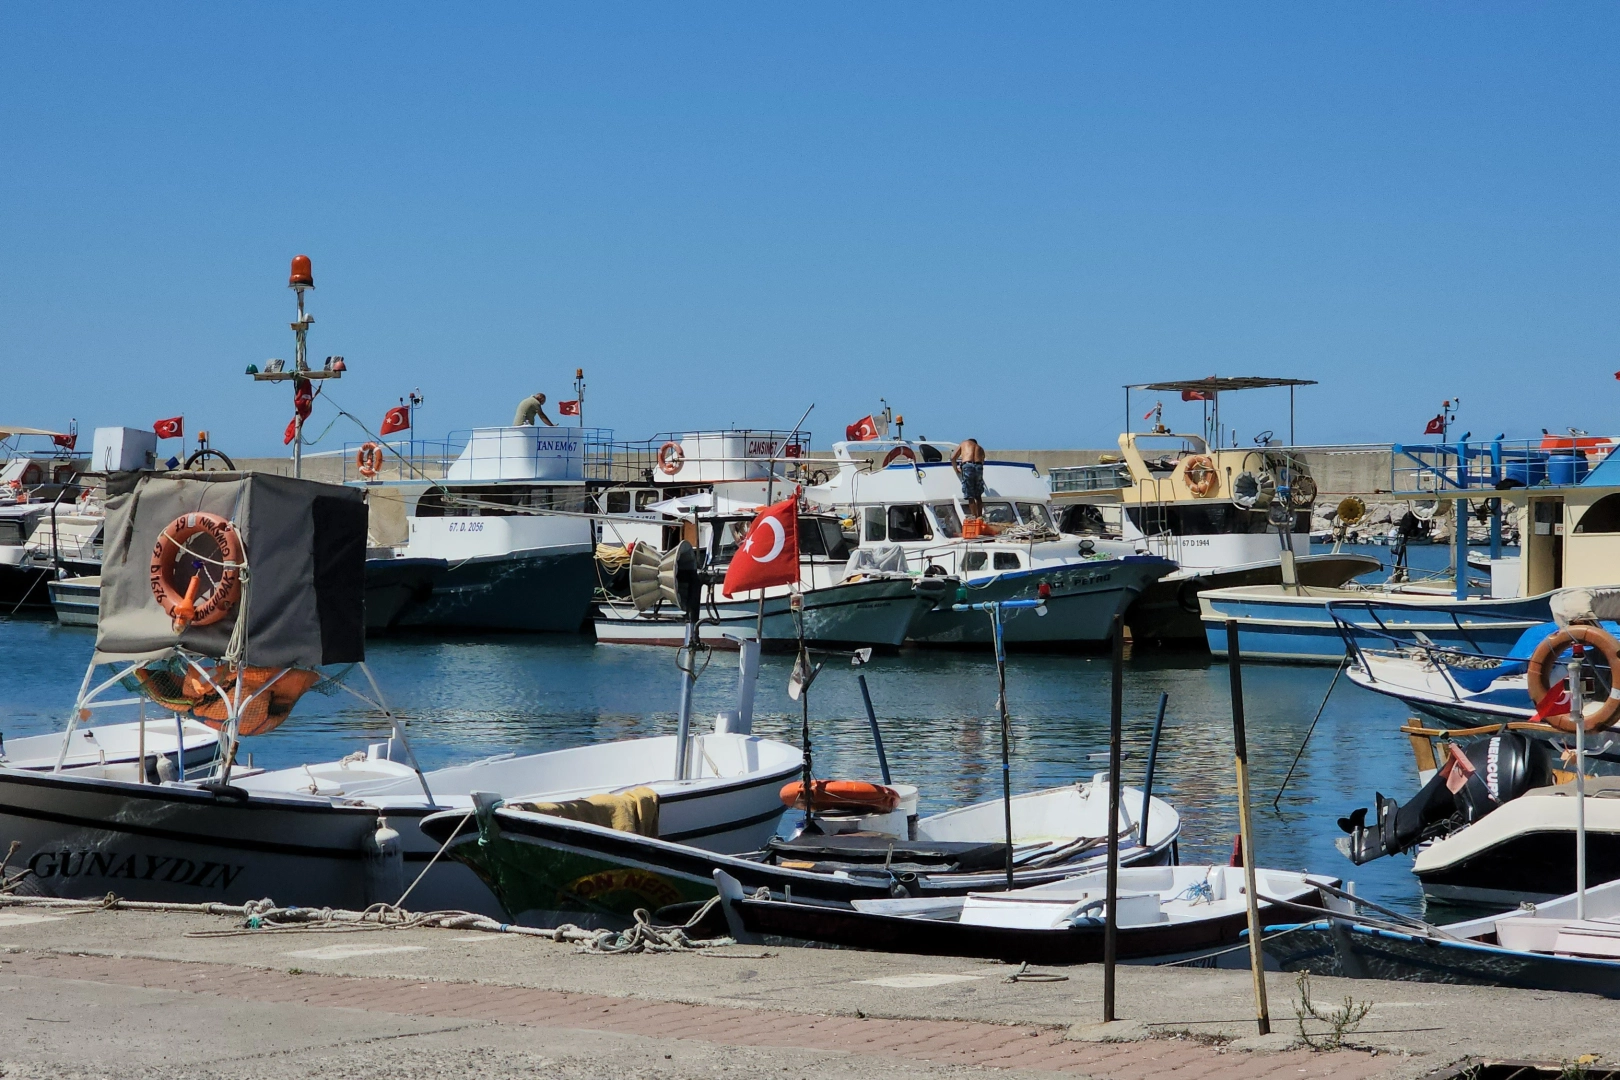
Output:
[910,555,1175,648]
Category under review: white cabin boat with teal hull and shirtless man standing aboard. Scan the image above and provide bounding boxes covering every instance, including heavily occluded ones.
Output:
[805,439,1175,648]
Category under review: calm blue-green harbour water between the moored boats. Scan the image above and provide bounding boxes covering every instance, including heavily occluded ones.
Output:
[0,549,1503,913]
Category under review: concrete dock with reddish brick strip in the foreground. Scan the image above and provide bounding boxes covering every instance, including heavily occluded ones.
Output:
[0,907,1620,1080]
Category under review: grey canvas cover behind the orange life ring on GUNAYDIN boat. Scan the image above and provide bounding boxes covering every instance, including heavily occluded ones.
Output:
[96,473,366,667]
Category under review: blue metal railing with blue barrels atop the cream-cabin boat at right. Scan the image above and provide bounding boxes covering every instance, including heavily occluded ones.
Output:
[1390,436,1620,499]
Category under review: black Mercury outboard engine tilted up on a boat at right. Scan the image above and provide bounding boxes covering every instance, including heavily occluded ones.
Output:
[1338,732,1552,866]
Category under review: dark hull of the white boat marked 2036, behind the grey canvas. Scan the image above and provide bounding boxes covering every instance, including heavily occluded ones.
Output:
[377,547,596,633]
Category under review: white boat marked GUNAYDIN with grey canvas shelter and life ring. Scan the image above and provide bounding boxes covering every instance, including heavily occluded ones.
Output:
[0,473,797,913]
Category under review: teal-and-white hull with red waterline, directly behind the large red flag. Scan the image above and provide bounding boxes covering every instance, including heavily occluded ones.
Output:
[596,578,944,651]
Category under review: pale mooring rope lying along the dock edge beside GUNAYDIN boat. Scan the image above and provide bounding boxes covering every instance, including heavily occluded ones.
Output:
[0,892,737,955]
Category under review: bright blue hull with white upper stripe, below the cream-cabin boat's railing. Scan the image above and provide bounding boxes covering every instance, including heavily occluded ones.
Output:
[1199,586,1552,664]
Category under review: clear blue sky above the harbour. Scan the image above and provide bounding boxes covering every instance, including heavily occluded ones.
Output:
[0,3,1620,452]
